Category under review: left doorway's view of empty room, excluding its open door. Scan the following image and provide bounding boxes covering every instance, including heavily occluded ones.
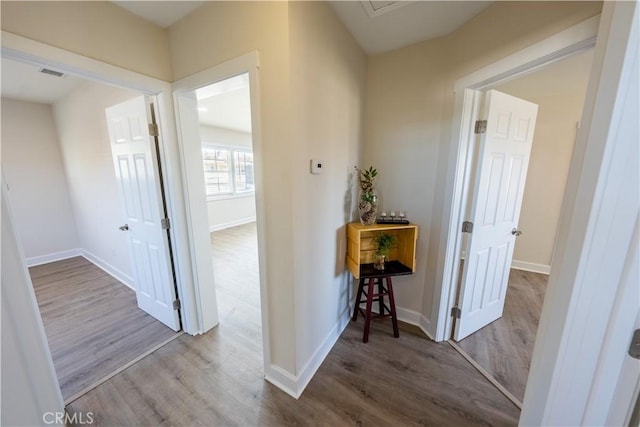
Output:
[2,56,181,403]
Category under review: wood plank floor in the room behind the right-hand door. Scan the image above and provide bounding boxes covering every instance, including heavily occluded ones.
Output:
[458,269,549,402]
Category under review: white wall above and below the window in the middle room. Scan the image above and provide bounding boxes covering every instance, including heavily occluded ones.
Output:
[200,125,256,231]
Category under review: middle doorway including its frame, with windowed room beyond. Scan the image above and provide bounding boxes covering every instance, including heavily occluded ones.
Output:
[173,52,270,375]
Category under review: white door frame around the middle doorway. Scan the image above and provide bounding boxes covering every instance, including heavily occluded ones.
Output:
[173,51,271,372]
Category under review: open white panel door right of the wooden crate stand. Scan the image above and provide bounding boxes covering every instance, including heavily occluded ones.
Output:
[453,90,538,340]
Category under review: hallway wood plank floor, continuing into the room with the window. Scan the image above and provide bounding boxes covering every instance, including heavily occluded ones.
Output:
[68,224,519,426]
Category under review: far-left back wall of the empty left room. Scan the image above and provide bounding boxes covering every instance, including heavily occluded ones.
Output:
[2,98,79,265]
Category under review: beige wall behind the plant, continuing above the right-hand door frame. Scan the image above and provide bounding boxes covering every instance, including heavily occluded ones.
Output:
[362,2,601,326]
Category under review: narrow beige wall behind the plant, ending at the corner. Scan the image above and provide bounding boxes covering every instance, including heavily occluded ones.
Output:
[361,39,449,312]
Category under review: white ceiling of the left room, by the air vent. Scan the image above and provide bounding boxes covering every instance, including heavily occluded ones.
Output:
[0,58,83,104]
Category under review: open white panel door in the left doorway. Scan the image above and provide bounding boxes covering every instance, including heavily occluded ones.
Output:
[106,96,180,331]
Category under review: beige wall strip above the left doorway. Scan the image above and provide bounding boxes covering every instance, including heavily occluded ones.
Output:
[0,1,172,82]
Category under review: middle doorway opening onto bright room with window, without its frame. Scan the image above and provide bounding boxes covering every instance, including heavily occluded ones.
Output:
[195,73,262,342]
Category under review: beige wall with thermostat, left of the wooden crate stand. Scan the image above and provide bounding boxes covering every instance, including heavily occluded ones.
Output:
[289,2,366,374]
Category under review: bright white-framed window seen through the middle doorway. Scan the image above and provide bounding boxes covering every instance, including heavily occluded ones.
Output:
[202,146,255,197]
